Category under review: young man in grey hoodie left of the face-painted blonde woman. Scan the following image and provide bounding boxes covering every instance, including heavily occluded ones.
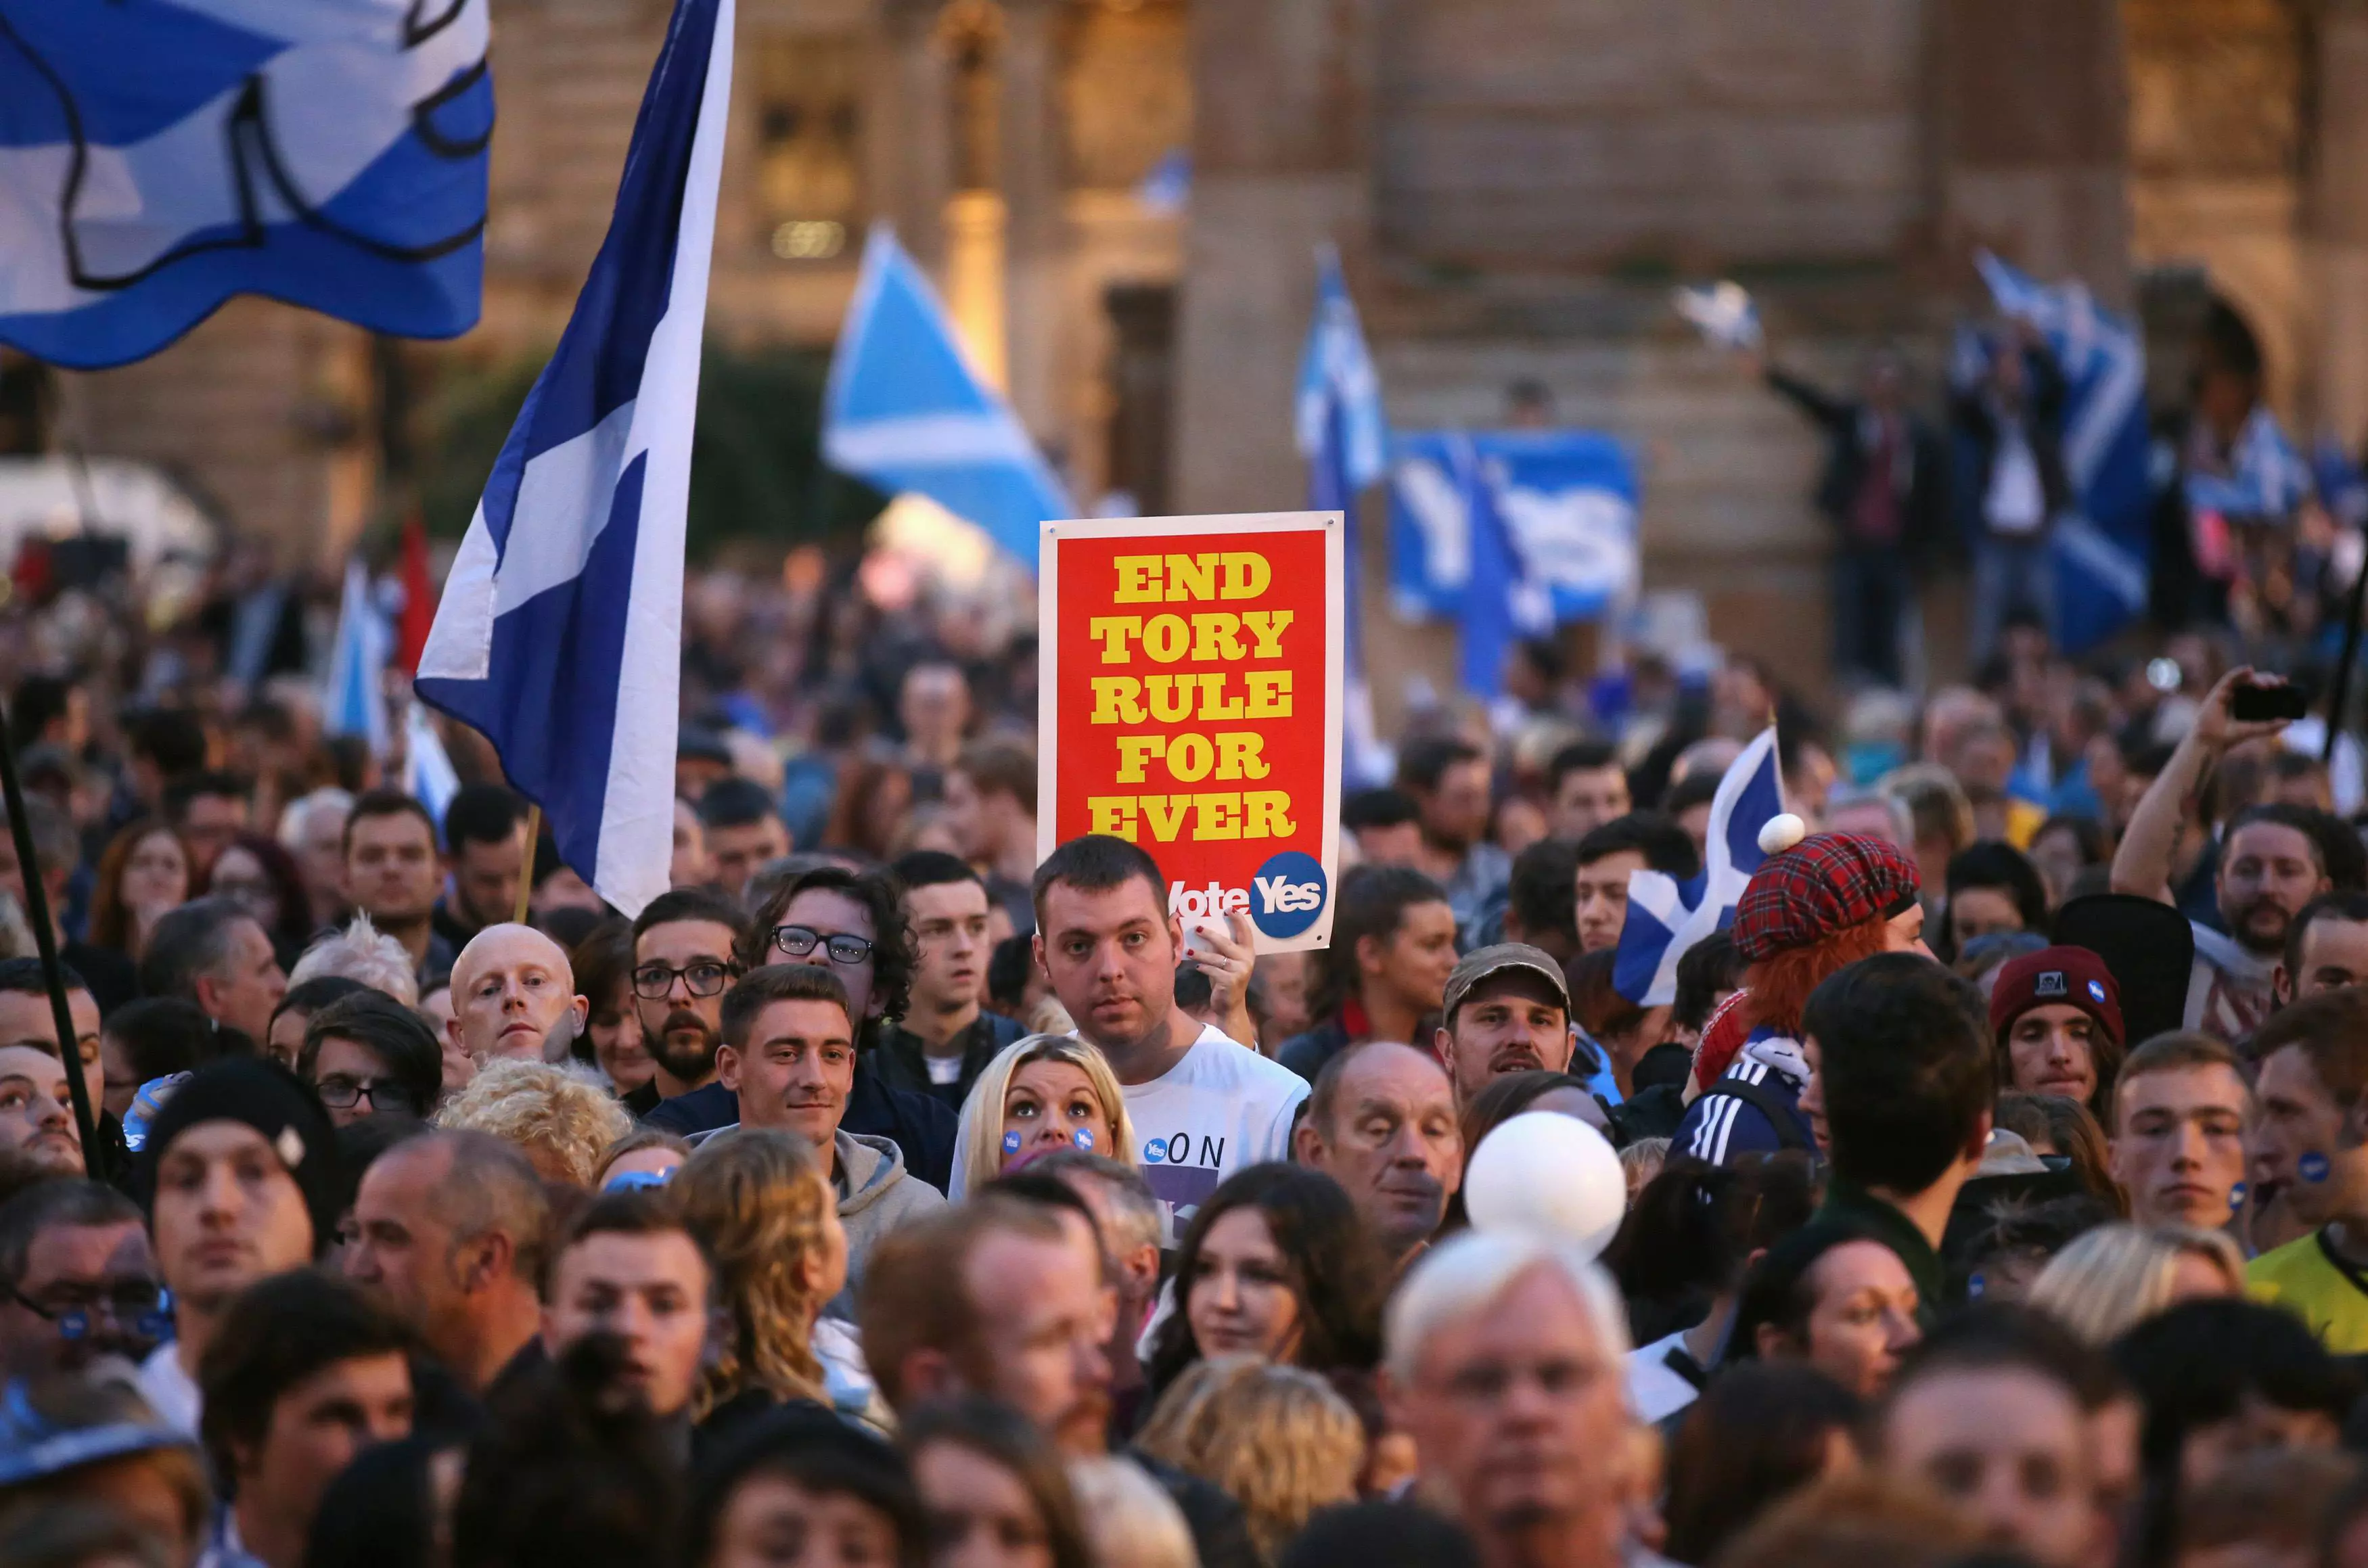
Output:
[713,964,945,1317]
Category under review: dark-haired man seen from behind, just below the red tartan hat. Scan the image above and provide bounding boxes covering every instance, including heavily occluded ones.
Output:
[1800,952,1997,1317]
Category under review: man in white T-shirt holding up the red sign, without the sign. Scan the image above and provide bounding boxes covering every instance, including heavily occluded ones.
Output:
[1035,834,1307,1239]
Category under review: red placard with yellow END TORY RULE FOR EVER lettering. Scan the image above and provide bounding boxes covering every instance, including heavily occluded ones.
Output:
[1037,511,1345,952]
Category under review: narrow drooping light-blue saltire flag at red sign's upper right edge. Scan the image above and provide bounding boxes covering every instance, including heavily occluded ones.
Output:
[1293,244,1392,784]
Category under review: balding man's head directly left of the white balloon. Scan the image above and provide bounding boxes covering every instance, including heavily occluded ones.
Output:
[1293,1040,1463,1262]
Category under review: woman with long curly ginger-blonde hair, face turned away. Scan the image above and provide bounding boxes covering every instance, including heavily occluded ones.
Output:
[668,1128,886,1426]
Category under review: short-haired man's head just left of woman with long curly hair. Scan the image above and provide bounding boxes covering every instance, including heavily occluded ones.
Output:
[543,1189,715,1421]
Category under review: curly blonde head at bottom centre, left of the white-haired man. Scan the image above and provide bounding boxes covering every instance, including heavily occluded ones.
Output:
[1137,1357,1364,1563]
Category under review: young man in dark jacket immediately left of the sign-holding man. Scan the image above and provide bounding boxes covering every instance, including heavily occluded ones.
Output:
[871,850,1026,1111]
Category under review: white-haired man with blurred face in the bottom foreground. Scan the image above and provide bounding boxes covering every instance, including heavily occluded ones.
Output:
[1383,1232,1637,1568]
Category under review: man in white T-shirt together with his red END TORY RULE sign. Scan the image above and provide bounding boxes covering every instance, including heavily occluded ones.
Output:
[1035,511,1343,1241]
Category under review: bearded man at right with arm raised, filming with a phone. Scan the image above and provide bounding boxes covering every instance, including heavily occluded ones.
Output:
[2112,668,2335,1040]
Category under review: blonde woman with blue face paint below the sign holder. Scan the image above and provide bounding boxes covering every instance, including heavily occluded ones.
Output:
[945,1035,1137,1203]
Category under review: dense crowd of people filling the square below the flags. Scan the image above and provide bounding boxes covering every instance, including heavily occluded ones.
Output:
[0,537,2368,1568]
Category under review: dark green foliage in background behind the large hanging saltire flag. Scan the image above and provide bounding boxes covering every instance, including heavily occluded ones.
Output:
[417,341,888,561]
